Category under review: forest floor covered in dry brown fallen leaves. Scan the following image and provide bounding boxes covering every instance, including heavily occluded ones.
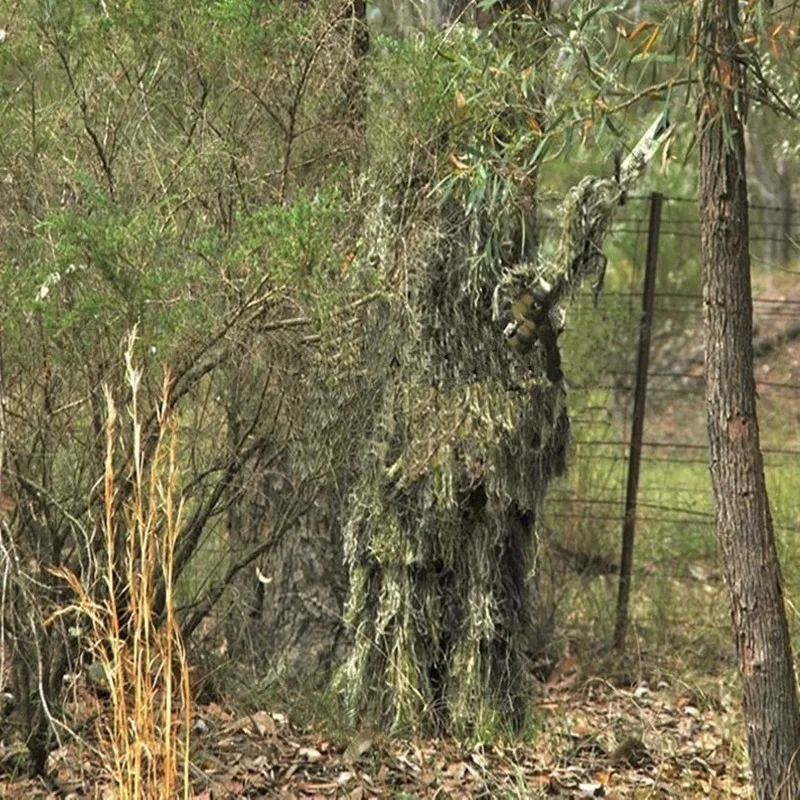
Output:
[0,658,751,800]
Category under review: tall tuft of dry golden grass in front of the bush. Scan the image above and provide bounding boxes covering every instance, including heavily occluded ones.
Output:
[51,336,191,800]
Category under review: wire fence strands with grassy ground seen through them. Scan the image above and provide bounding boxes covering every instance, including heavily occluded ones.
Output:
[544,196,800,612]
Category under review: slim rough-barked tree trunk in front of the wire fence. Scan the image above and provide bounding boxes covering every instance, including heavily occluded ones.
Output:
[697,0,800,800]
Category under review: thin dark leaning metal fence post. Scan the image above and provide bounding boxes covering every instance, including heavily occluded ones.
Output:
[614,192,663,650]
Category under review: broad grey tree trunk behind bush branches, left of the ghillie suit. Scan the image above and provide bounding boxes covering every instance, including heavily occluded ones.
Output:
[217,339,352,697]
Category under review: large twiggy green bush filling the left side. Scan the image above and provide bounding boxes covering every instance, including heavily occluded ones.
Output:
[0,0,376,764]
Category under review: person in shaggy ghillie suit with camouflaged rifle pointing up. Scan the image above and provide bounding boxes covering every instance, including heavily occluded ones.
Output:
[339,115,664,732]
